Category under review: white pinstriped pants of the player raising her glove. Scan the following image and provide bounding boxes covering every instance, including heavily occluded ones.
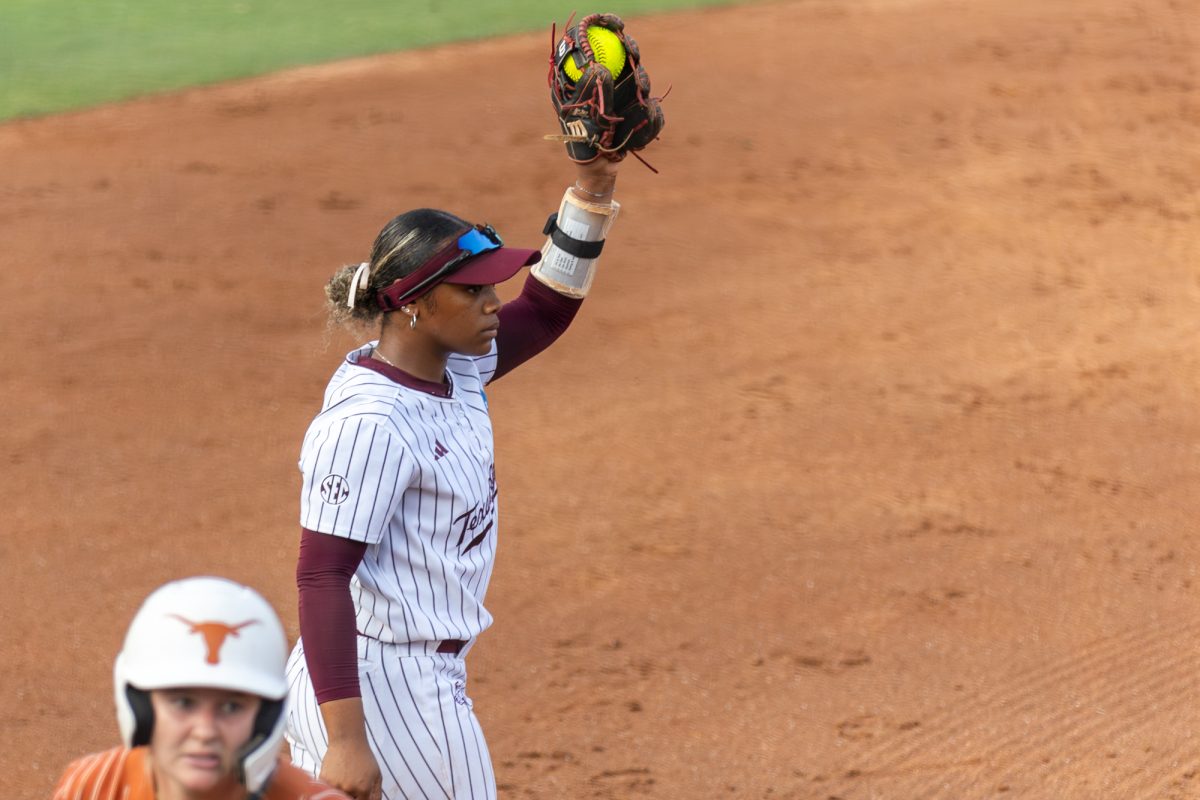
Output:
[287,636,496,800]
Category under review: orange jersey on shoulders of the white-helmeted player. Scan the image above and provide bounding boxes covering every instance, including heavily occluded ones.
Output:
[53,747,348,800]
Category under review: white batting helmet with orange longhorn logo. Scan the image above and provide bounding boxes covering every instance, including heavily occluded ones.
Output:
[113,577,288,795]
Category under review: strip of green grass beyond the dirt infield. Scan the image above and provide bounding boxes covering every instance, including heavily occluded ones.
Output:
[0,0,731,120]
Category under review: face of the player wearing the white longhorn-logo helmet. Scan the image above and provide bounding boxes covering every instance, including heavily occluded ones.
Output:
[150,688,262,798]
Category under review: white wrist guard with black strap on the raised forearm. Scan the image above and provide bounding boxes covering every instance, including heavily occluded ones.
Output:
[530,190,620,297]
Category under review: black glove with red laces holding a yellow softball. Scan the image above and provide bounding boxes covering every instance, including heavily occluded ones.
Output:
[546,14,666,164]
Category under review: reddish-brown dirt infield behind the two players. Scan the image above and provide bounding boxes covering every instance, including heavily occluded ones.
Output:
[0,0,1200,800]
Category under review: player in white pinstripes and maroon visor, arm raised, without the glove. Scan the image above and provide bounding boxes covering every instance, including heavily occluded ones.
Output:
[280,151,619,800]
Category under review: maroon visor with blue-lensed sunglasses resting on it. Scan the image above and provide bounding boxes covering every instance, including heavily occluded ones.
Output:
[378,225,541,311]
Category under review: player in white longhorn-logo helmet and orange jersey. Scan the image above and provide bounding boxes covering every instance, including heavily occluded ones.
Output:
[54,578,346,800]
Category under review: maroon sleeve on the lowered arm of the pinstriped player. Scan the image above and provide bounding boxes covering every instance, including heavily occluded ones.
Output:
[296,528,367,703]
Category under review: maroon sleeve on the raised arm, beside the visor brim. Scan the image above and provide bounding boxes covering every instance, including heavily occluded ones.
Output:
[492,275,583,380]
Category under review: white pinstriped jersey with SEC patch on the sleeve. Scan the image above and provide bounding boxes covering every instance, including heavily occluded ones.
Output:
[300,342,497,642]
